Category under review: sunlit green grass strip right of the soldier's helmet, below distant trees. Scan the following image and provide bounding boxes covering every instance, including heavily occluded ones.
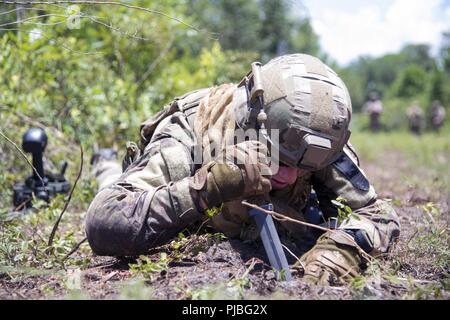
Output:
[350,126,450,196]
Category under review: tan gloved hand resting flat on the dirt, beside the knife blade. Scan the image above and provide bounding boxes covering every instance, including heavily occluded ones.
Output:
[300,233,361,286]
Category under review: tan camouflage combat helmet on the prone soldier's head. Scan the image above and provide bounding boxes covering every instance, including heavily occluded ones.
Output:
[233,54,352,171]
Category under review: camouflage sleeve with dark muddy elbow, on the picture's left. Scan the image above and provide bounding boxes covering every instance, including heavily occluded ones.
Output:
[86,138,202,256]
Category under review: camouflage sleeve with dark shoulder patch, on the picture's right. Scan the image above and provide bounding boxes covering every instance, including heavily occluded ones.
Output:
[313,145,400,256]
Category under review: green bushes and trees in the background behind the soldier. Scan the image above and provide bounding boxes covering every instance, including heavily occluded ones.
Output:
[0,0,450,145]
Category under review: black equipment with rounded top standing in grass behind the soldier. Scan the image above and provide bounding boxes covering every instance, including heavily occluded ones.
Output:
[13,128,70,210]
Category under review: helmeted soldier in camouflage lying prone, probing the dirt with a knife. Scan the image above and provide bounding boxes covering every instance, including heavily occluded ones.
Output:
[86,54,400,285]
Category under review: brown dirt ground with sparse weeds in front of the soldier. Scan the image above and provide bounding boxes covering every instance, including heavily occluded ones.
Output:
[0,141,450,299]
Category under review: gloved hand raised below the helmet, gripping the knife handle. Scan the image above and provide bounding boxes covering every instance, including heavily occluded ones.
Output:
[190,141,271,210]
